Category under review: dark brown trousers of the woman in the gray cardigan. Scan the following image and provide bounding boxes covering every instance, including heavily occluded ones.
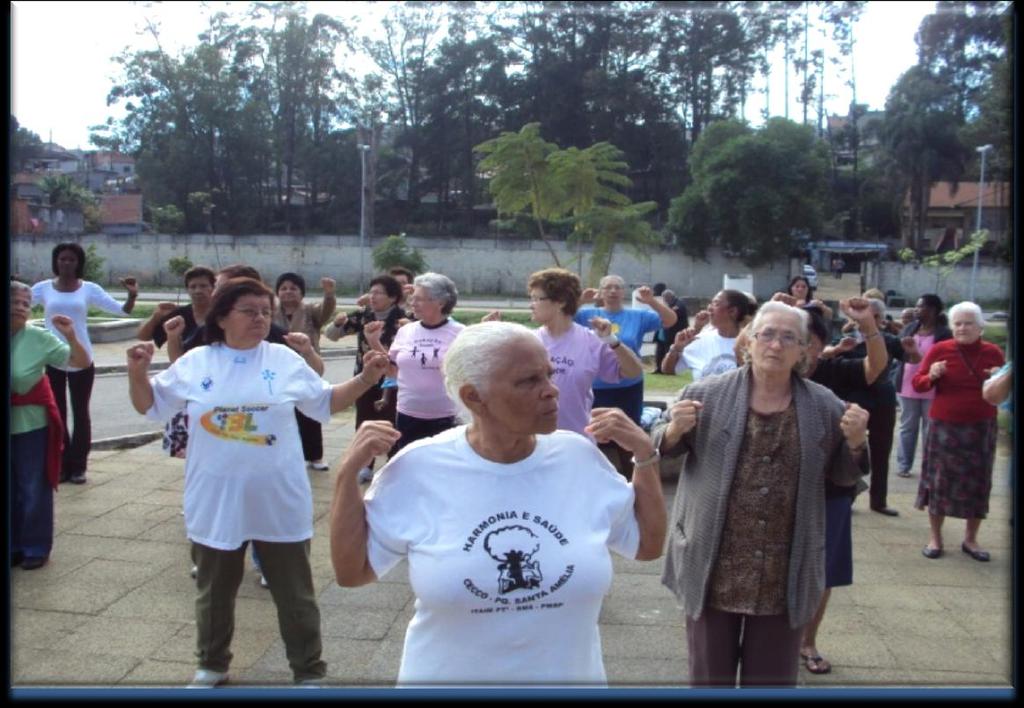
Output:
[686,608,803,689]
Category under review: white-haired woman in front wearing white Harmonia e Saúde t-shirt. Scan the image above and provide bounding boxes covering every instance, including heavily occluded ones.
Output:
[323,322,666,686]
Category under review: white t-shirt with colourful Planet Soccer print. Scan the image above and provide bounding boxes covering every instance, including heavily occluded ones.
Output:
[146,341,331,550]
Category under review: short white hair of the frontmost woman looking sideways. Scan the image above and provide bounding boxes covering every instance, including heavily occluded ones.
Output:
[444,321,544,420]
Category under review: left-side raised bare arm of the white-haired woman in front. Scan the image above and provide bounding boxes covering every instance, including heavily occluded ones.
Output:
[331,420,400,587]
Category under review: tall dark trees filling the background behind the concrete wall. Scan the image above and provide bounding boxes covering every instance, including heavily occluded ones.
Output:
[11,0,1013,260]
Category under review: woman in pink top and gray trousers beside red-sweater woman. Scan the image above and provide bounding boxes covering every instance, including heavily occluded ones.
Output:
[893,293,953,477]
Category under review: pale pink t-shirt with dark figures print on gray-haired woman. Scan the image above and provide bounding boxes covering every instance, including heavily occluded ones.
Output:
[388,320,466,420]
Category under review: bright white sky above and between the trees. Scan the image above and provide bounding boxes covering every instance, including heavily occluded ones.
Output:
[10,0,935,149]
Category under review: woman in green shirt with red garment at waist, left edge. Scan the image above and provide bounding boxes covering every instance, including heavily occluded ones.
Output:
[10,281,90,571]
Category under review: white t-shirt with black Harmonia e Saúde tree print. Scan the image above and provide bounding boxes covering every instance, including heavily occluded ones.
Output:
[366,426,640,686]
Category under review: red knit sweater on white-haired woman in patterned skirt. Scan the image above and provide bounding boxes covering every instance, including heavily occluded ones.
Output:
[910,339,1005,423]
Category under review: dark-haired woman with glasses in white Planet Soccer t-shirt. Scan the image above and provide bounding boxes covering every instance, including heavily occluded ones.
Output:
[128,278,387,688]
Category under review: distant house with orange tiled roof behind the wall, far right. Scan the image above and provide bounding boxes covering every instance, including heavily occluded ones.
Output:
[902,181,1012,252]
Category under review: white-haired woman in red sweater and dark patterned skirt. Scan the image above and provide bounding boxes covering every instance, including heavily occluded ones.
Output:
[911,302,1004,560]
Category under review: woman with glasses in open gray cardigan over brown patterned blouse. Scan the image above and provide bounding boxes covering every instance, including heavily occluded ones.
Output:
[652,302,869,686]
